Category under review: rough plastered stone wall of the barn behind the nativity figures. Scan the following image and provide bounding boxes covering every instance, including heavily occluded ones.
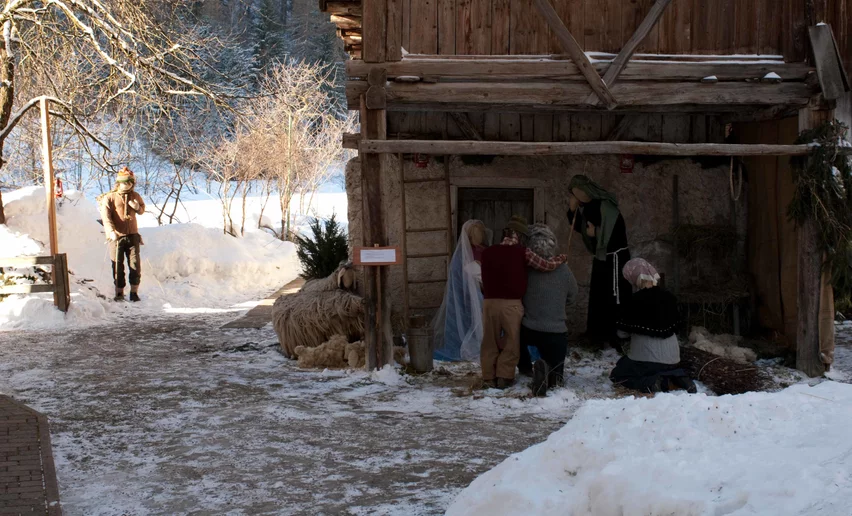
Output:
[347,156,746,332]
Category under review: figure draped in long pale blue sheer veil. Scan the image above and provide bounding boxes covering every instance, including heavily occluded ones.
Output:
[432,220,490,361]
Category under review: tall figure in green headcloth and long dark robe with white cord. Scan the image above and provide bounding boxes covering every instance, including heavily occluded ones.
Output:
[568,175,633,349]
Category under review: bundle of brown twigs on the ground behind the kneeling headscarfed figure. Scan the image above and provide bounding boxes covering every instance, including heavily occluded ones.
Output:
[680,347,771,395]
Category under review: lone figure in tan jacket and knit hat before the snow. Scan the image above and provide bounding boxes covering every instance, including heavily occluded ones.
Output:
[100,167,145,301]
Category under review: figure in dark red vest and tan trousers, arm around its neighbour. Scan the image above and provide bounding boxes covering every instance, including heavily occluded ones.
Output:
[480,216,568,389]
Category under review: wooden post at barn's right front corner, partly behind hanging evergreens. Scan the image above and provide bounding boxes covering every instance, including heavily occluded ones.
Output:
[796,109,834,376]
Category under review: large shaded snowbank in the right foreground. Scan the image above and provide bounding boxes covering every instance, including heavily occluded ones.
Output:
[447,382,852,516]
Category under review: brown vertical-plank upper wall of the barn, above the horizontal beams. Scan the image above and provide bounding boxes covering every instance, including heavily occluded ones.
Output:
[400,0,852,66]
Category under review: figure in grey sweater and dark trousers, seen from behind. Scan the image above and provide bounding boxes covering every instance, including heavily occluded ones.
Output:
[518,224,577,396]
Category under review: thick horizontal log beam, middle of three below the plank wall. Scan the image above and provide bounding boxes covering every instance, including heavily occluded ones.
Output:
[346,81,814,111]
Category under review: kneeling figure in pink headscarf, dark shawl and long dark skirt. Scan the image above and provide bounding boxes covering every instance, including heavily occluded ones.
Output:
[609,258,696,393]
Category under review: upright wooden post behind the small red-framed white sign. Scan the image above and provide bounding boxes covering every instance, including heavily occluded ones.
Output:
[361,95,393,370]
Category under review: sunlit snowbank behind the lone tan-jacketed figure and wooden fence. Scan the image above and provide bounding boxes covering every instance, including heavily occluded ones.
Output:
[0,187,300,329]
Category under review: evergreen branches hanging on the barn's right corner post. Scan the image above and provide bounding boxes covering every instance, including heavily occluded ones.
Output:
[787,120,852,297]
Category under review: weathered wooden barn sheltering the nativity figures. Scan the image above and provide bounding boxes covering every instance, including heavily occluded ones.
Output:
[320,0,852,375]
